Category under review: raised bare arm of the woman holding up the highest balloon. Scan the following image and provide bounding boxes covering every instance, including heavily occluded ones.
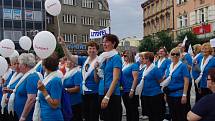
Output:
[58,36,78,63]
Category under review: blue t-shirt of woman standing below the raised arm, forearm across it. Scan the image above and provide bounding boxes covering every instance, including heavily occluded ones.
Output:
[63,71,82,105]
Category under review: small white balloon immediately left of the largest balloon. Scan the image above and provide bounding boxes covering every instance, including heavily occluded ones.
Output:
[19,36,32,50]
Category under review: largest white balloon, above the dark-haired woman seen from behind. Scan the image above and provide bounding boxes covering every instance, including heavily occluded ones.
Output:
[33,31,56,59]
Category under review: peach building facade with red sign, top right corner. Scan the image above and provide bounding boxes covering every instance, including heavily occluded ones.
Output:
[174,0,215,39]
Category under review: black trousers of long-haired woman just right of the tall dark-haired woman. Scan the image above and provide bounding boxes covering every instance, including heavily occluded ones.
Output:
[122,92,139,121]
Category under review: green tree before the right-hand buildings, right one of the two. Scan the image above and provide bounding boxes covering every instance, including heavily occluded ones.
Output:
[156,31,173,51]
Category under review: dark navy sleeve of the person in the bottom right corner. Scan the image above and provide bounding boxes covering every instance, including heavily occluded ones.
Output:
[191,96,212,117]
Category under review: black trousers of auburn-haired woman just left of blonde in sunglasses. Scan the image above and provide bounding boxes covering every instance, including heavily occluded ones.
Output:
[141,94,165,121]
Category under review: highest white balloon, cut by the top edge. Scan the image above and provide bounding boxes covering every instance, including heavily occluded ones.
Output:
[45,0,61,16]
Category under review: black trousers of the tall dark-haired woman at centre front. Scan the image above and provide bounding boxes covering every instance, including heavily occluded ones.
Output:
[100,95,122,121]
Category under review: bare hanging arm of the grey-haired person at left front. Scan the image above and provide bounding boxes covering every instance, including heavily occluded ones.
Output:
[20,94,36,121]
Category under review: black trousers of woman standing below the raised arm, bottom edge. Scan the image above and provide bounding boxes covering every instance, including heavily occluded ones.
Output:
[71,103,83,121]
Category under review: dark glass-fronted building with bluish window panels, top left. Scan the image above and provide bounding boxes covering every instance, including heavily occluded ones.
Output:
[0,0,46,49]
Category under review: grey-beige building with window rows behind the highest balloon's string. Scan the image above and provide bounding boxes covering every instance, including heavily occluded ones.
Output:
[47,0,110,54]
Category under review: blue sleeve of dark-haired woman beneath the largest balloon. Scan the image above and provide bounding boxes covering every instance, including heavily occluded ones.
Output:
[50,78,63,100]
